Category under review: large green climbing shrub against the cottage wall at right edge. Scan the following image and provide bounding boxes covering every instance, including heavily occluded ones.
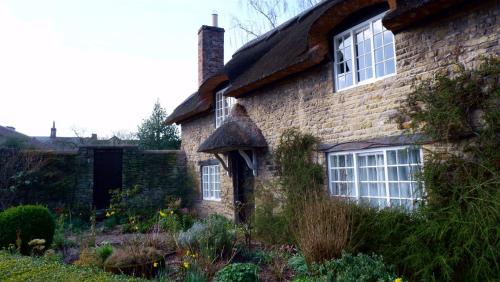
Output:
[394,57,500,281]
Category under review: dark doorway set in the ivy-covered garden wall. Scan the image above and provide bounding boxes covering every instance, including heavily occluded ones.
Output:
[93,149,122,210]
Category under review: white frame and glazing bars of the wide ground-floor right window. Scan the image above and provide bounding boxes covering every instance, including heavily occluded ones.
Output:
[327,146,425,209]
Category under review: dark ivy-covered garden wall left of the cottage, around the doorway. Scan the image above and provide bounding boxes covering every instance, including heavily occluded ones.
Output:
[0,146,187,214]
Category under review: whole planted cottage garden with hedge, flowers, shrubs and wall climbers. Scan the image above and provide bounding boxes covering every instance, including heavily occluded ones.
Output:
[0,59,500,282]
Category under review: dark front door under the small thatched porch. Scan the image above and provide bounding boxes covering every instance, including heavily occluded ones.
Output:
[230,151,254,222]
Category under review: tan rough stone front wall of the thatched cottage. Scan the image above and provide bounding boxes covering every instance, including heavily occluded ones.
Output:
[182,1,500,218]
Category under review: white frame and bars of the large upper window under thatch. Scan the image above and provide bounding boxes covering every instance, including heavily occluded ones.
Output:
[333,12,398,92]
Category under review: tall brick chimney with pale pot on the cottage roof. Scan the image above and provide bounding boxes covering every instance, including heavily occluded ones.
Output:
[198,14,224,85]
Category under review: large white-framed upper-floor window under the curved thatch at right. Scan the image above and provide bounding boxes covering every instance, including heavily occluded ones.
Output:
[333,13,396,91]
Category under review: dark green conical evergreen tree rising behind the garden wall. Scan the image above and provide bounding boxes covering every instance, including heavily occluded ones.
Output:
[137,101,181,150]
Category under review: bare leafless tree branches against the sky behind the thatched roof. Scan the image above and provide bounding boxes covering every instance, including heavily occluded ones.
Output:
[233,0,322,44]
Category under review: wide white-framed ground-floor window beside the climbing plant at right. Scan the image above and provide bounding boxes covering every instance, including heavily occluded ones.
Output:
[328,147,423,209]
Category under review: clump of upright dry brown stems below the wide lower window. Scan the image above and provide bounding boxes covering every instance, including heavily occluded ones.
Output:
[295,192,353,264]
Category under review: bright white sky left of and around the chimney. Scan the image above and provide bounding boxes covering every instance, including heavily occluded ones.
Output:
[0,0,258,137]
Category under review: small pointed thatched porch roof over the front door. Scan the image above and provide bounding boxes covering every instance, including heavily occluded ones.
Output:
[198,104,267,153]
